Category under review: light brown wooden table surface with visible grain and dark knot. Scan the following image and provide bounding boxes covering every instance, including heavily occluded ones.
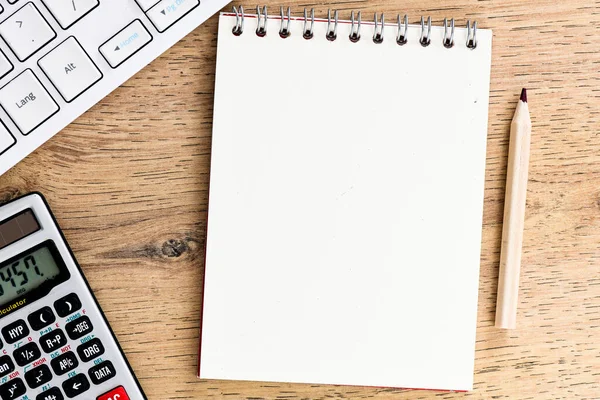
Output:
[0,0,600,400]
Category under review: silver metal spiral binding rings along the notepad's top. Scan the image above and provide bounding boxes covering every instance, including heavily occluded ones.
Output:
[231,6,477,49]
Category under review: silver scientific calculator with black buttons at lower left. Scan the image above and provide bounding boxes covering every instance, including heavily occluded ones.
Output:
[0,193,146,400]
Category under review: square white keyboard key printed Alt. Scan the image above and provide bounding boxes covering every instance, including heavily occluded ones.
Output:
[38,36,102,103]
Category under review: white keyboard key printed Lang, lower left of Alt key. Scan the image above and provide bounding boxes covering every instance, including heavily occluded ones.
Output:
[0,69,59,135]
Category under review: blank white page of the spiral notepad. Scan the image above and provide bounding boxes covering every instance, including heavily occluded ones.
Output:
[199,14,492,390]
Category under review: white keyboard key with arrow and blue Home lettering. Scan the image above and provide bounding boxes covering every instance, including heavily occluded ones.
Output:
[98,19,152,68]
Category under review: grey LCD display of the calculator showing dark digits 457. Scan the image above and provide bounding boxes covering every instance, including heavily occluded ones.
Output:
[0,246,61,304]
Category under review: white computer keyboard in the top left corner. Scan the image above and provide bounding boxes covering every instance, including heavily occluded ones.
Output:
[0,0,230,175]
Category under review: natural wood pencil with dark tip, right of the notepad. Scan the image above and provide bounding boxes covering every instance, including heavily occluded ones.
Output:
[496,89,531,329]
